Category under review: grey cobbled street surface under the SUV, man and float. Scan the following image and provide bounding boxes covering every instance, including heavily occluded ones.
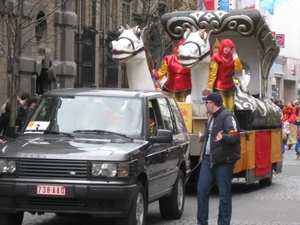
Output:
[23,147,300,225]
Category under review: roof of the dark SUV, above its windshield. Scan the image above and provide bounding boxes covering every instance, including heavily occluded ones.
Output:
[43,88,172,98]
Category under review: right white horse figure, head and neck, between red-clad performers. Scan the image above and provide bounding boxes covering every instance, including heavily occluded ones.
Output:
[178,28,211,117]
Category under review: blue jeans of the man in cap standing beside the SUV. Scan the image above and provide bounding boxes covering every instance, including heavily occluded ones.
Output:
[197,155,234,225]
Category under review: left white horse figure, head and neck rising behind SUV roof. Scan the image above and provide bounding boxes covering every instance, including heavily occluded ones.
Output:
[111,25,156,90]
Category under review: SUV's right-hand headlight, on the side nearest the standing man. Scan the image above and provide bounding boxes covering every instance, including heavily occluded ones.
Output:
[92,163,129,177]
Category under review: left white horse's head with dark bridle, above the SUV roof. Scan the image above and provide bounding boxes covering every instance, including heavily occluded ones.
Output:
[111,25,147,63]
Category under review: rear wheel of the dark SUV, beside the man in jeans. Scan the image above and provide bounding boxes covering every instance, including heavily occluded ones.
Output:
[159,171,185,219]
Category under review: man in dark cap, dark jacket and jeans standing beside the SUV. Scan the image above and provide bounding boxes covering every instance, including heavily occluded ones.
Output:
[197,92,240,225]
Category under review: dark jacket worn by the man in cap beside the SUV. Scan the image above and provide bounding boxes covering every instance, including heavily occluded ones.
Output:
[201,106,241,165]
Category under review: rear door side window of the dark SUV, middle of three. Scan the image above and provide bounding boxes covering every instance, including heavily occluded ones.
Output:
[158,98,177,134]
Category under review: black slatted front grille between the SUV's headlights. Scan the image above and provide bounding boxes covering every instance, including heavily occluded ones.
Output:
[19,159,89,180]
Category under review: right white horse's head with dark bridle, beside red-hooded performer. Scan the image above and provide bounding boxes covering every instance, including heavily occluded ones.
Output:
[178,27,210,68]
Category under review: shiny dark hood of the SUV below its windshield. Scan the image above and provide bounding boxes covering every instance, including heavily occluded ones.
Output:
[0,135,148,161]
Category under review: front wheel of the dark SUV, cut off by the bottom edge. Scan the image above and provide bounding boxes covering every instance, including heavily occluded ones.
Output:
[115,182,146,225]
